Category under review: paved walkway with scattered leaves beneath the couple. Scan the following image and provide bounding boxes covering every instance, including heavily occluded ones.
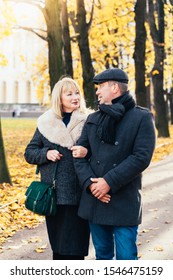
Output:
[0,154,173,260]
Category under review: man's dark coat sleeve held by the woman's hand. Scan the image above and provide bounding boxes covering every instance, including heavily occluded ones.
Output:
[73,122,96,190]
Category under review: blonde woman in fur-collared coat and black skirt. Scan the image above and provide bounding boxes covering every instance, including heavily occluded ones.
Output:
[25,77,89,260]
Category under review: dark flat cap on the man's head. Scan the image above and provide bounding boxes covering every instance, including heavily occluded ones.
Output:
[93,68,129,84]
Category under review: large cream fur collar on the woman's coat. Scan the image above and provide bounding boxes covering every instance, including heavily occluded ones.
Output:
[37,109,87,148]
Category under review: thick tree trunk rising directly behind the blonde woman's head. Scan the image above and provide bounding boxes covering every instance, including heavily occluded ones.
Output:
[44,0,65,90]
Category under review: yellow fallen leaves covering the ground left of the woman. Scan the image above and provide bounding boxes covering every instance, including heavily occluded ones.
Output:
[0,119,44,248]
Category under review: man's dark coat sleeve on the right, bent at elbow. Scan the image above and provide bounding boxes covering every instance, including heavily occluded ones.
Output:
[104,112,156,193]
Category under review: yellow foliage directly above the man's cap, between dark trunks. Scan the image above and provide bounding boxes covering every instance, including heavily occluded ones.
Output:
[89,0,135,90]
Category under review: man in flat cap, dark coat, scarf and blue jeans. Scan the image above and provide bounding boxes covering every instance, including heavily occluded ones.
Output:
[74,68,155,260]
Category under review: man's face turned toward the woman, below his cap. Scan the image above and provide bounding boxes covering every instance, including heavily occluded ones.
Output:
[96,82,116,105]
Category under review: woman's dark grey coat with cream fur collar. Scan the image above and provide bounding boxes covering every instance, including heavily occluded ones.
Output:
[24,109,86,205]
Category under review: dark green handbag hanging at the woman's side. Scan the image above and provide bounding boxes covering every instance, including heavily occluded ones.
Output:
[25,161,58,216]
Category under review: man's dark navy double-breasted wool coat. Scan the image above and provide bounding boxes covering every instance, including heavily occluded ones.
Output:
[74,103,155,226]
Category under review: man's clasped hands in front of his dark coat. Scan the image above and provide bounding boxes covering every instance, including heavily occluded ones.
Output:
[89,178,111,203]
